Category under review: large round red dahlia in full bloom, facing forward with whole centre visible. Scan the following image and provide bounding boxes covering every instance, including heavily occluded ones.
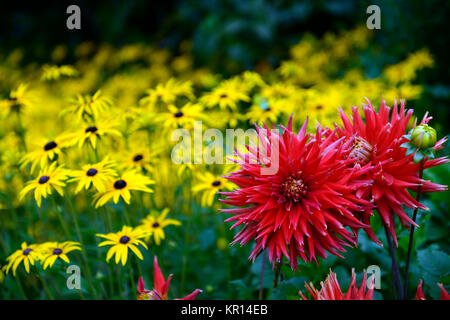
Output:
[221,118,370,269]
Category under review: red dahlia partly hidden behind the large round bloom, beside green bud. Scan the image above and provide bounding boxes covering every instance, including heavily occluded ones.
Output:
[335,100,448,246]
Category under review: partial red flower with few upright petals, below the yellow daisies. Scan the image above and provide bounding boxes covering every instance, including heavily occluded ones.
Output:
[137,256,202,300]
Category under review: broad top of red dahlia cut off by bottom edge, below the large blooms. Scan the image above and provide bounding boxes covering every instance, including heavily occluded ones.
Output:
[298,270,374,300]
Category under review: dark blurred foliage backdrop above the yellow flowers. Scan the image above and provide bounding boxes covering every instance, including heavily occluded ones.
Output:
[0,0,450,123]
